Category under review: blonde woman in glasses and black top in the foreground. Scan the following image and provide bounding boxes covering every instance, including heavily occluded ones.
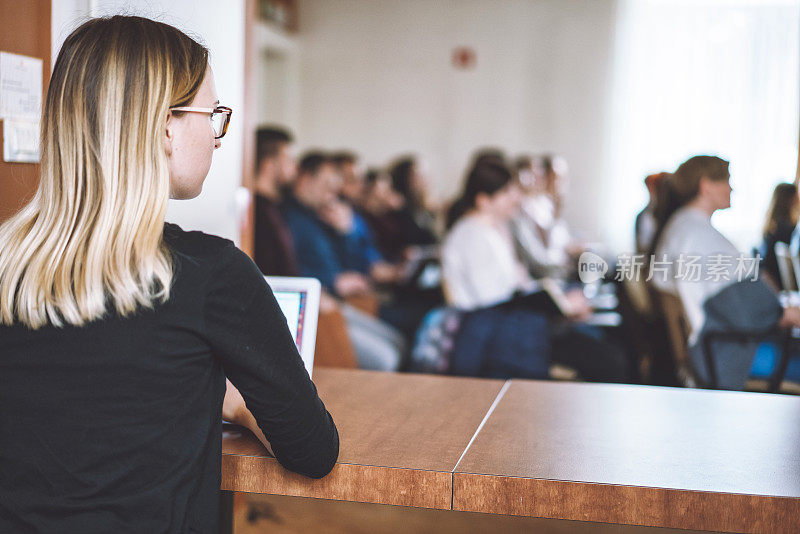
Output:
[0,16,338,533]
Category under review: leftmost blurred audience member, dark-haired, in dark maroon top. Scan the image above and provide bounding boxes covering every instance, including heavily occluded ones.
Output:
[254,128,298,276]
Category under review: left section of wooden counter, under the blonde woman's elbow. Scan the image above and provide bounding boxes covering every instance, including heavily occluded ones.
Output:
[221,369,504,510]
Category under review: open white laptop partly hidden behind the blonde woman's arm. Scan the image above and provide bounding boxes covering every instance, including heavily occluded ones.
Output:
[264,276,322,376]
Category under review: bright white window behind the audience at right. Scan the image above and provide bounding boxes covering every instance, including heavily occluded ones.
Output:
[605,0,800,251]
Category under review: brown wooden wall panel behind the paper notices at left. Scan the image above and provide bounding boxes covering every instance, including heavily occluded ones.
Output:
[0,0,51,222]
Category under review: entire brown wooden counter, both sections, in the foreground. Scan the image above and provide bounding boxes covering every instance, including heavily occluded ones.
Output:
[222,369,800,532]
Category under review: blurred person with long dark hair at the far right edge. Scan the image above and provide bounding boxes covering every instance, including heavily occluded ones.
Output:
[759,183,799,287]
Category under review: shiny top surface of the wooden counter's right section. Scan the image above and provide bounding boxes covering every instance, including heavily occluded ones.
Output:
[456,380,800,498]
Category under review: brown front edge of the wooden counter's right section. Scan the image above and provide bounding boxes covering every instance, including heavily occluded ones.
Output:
[453,473,800,533]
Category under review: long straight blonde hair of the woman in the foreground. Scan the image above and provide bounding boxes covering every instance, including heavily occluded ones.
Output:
[0,16,208,329]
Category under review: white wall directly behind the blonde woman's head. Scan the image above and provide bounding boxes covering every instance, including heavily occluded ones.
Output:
[52,0,245,239]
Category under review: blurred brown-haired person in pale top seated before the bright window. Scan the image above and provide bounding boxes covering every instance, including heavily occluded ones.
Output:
[651,156,800,389]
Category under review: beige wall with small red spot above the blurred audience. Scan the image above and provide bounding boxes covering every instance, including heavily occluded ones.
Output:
[291,0,616,245]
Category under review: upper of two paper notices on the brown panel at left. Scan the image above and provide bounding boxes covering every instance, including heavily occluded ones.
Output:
[0,52,42,120]
